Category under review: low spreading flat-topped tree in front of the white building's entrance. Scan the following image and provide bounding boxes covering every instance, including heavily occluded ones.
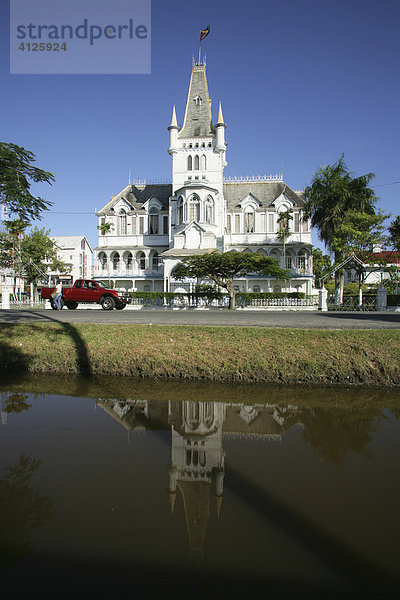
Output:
[171,250,290,309]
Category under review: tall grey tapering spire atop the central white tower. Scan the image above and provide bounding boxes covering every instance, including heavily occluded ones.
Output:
[178,62,215,138]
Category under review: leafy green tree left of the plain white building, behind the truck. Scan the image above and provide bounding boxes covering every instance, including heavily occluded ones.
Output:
[21,227,68,295]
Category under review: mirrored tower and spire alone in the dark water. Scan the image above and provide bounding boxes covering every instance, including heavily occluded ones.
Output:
[169,401,226,555]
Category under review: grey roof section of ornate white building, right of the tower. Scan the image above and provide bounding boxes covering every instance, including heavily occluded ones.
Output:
[224,181,305,210]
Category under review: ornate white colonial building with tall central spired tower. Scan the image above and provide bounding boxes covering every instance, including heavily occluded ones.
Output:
[94,61,313,294]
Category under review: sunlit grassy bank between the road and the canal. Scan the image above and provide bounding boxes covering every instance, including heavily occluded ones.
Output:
[0,322,400,386]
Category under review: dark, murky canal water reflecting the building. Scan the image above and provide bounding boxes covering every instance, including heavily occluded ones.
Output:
[0,378,400,599]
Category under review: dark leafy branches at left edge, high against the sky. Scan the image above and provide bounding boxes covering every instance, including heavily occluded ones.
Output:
[0,142,54,223]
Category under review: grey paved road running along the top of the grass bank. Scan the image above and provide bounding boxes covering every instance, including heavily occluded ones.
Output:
[0,309,400,329]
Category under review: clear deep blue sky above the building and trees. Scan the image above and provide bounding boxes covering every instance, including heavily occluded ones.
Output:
[0,0,400,253]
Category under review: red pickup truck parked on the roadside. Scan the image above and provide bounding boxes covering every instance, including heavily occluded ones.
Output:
[41,279,129,310]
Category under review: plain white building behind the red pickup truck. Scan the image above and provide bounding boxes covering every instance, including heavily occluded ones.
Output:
[49,235,93,282]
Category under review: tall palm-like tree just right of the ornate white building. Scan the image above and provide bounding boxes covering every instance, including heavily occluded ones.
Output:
[304,155,377,304]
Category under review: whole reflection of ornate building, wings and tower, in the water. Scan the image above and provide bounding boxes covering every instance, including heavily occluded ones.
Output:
[97,400,309,555]
